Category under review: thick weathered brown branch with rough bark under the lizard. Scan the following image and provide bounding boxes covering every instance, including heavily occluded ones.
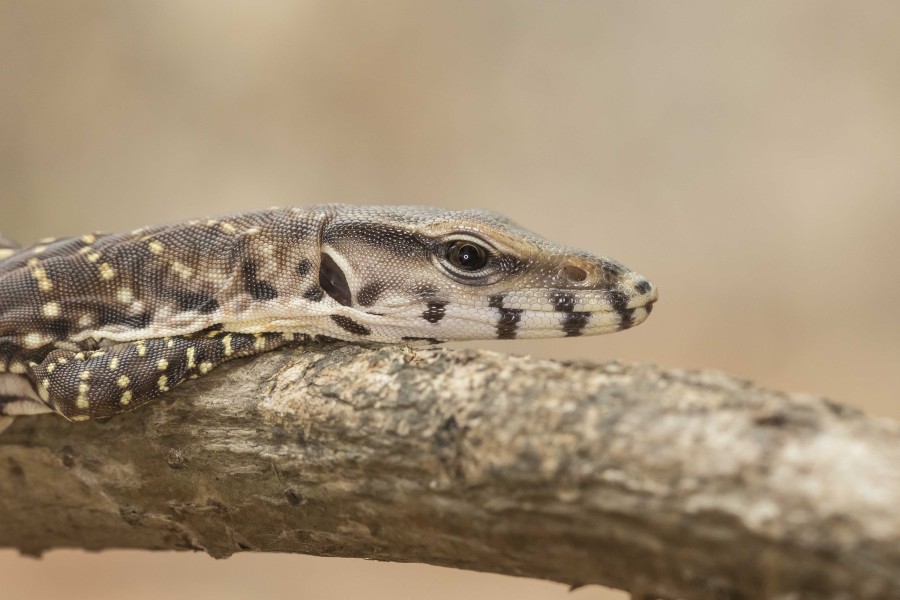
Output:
[0,345,900,599]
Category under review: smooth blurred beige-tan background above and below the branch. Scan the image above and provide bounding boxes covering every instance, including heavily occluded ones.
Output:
[0,0,900,600]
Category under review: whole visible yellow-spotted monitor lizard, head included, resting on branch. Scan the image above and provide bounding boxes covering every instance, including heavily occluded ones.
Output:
[0,205,657,421]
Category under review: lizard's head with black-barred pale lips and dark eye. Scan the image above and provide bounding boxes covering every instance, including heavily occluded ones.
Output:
[319,207,657,342]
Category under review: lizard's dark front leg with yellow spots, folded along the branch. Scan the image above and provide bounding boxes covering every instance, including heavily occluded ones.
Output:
[30,331,293,421]
